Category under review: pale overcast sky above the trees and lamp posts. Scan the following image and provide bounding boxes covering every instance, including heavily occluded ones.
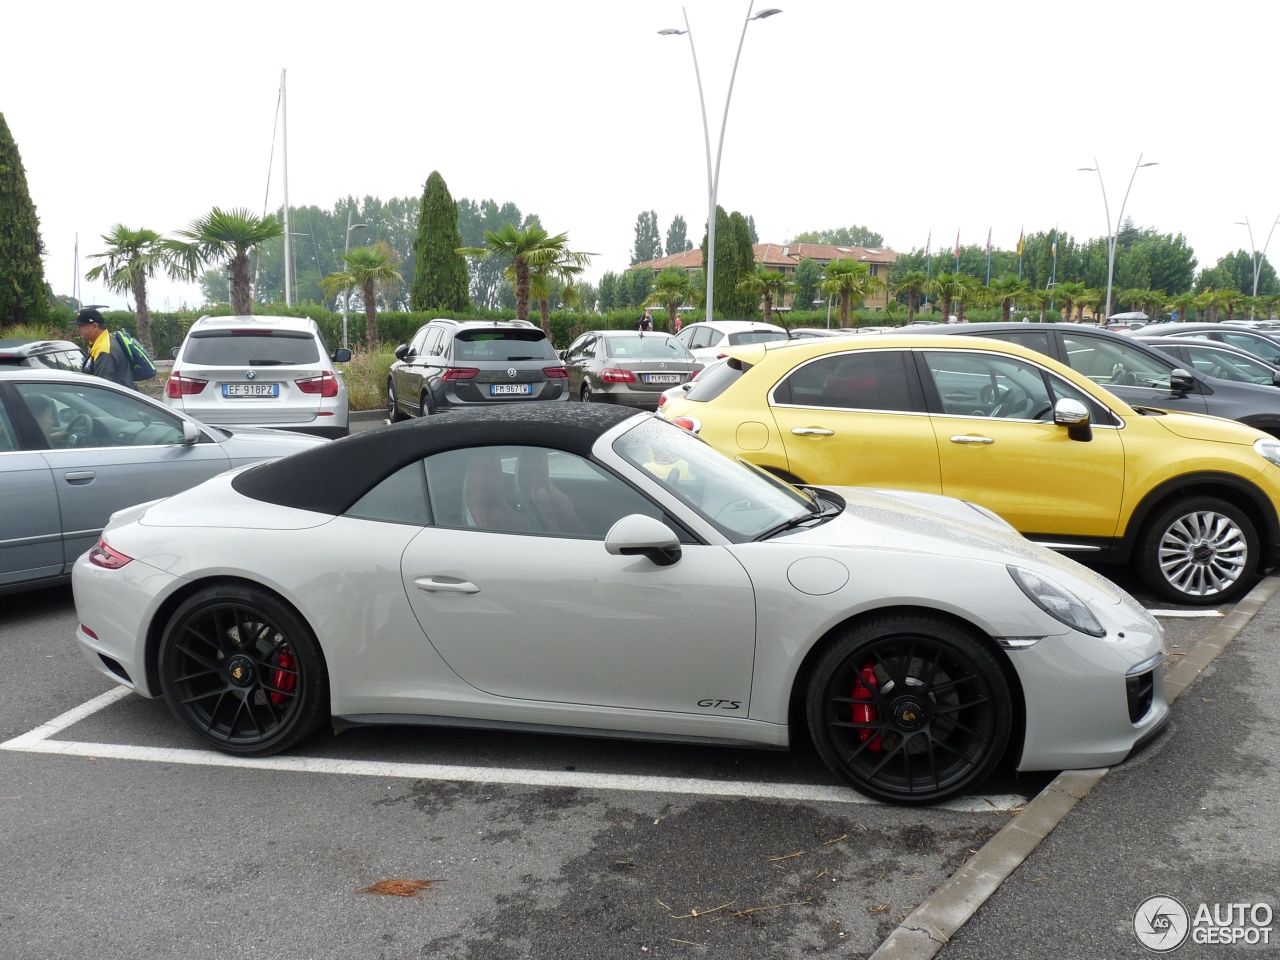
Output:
[0,0,1280,310]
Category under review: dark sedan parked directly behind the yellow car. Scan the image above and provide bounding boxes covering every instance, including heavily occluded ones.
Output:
[904,324,1280,438]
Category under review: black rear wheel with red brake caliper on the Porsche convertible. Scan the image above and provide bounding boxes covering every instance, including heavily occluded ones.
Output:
[160,584,329,755]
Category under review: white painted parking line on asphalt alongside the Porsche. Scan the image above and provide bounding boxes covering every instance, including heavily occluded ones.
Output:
[0,687,1027,813]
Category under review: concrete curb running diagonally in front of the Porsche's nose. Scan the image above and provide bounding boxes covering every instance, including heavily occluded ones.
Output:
[872,576,1280,960]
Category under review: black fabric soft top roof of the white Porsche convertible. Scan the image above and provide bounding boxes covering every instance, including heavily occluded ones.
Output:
[232,403,636,516]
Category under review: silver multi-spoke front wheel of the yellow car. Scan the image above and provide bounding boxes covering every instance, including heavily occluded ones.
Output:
[1134,497,1261,605]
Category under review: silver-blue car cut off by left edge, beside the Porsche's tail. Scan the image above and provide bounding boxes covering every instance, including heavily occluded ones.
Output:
[0,367,324,594]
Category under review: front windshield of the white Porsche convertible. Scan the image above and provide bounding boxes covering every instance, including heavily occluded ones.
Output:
[613,419,815,541]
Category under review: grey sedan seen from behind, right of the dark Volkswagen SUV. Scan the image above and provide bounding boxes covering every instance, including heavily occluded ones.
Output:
[564,330,703,410]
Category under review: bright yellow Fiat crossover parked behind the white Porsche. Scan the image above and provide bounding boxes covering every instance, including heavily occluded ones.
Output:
[662,335,1280,604]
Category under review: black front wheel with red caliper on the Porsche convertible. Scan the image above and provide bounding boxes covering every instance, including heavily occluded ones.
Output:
[806,614,1012,805]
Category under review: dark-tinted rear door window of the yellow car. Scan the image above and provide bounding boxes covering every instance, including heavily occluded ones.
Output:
[774,351,914,411]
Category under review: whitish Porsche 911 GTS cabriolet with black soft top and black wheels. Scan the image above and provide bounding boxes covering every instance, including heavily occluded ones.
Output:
[73,404,1169,803]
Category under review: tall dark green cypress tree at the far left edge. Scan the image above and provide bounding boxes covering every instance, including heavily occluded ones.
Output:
[0,114,49,326]
